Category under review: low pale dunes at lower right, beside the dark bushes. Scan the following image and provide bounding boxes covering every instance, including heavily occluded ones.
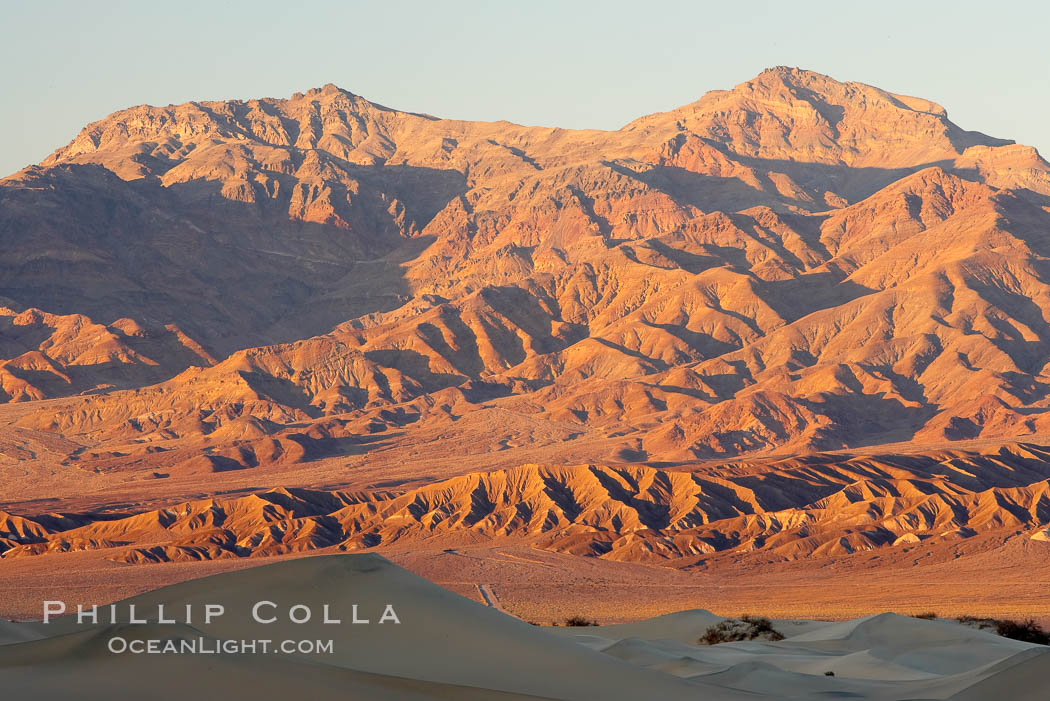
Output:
[551,611,1050,701]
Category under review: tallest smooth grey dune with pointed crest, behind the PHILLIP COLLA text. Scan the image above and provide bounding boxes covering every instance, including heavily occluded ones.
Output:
[12,555,744,699]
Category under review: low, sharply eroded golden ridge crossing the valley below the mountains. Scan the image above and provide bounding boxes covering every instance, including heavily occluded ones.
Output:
[6,444,1050,569]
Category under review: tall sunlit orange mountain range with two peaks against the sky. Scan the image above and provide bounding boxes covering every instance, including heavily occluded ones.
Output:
[0,66,1050,484]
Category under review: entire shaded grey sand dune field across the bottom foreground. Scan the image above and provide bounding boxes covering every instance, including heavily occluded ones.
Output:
[0,554,1050,701]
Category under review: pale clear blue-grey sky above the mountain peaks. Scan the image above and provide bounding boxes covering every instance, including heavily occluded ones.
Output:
[0,0,1050,175]
